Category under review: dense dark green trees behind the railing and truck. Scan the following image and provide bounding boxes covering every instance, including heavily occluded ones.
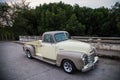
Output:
[0,0,120,40]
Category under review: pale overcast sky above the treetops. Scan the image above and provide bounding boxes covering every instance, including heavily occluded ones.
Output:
[0,0,120,8]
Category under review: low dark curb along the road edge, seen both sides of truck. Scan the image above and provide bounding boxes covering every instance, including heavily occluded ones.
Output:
[13,41,120,60]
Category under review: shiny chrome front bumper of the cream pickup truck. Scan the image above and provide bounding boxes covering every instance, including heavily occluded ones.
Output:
[82,56,98,72]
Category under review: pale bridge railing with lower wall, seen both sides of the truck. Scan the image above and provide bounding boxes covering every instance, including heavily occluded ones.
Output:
[19,36,120,51]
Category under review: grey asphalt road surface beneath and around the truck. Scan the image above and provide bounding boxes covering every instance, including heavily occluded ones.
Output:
[0,42,120,80]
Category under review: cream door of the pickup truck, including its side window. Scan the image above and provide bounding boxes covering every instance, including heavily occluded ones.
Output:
[36,34,57,60]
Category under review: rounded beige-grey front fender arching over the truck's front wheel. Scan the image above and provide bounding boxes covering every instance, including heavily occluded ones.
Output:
[56,51,84,70]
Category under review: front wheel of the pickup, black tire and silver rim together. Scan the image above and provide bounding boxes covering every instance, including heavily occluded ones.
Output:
[62,60,76,74]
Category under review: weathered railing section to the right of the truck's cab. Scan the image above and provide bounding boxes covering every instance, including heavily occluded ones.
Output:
[72,36,120,51]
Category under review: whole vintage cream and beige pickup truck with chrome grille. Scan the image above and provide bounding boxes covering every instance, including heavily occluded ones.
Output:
[23,31,98,73]
